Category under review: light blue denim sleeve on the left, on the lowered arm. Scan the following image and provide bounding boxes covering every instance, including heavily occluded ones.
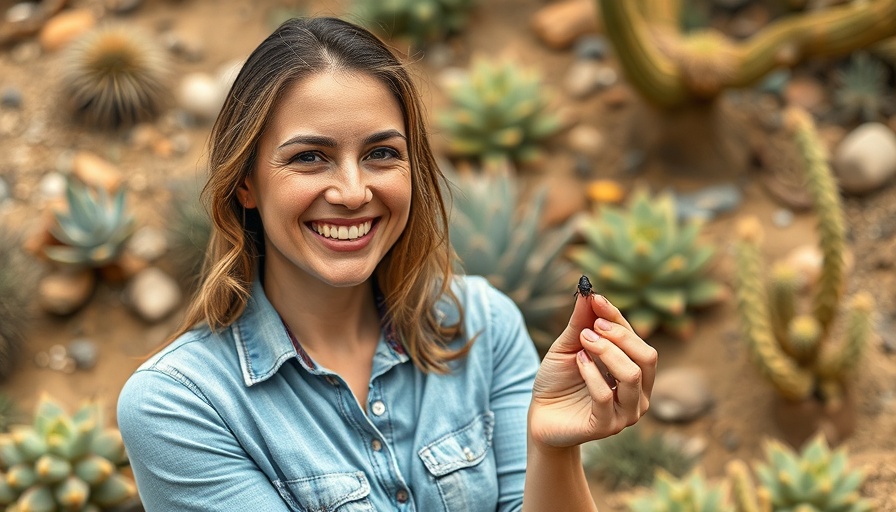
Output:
[118,368,289,512]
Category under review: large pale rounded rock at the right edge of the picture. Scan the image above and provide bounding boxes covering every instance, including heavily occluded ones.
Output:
[832,122,896,195]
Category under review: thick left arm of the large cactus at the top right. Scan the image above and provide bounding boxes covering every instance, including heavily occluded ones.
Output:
[595,0,689,107]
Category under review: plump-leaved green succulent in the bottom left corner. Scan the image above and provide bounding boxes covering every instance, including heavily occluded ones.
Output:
[0,396,137,512]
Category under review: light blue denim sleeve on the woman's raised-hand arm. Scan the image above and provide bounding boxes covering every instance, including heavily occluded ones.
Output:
[488,284,540,512]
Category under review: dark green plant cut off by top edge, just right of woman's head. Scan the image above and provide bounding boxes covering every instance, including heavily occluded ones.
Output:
[352,0,477,48]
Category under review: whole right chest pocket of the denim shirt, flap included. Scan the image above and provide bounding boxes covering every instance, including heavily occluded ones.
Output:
[417,411,498,511]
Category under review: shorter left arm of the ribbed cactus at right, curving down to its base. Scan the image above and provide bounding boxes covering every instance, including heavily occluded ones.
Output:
[735,217,815,400]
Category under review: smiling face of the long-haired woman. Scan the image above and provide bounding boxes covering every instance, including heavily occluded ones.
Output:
[239,71,411,286]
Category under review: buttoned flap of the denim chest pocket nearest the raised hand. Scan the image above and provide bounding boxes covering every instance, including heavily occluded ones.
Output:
[417,411,495,477]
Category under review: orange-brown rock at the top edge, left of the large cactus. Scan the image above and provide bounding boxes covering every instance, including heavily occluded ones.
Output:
[531,0,599,50]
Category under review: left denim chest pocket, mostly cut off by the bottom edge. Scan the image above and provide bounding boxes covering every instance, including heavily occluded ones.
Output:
[274,471,373,512]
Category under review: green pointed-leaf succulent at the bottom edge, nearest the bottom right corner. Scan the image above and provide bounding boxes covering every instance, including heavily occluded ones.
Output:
[756,435,874,512]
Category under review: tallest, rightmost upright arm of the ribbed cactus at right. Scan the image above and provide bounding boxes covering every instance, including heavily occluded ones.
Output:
[785,107,844,333]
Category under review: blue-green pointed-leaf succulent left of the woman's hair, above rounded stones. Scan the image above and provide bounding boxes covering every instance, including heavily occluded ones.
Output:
[44,174,134,268]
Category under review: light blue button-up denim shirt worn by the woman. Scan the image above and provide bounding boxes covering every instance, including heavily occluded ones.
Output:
[118,277,539,512]
